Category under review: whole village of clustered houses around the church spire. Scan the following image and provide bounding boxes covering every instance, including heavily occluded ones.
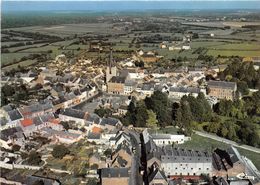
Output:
[0,44,260,185]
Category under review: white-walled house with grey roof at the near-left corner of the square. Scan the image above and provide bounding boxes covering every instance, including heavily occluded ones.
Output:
[59,108,88,127]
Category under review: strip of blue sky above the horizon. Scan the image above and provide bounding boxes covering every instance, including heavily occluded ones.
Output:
[2,0,260,12]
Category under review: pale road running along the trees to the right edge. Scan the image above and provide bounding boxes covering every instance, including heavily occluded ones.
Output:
[195,131,260,153]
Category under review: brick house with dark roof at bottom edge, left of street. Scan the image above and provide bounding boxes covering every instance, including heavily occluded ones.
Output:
[99,168,130,185]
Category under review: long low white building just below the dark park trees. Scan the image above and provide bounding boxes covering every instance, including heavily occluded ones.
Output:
[151,134,190,146]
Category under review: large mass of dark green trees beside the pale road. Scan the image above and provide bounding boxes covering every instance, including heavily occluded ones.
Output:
[122,91,260,146]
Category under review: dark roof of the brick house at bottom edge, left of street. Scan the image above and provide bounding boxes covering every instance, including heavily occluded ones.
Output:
[100,168,129,178]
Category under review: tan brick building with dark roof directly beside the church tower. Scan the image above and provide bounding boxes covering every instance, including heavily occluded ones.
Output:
[107,76,126,94]
